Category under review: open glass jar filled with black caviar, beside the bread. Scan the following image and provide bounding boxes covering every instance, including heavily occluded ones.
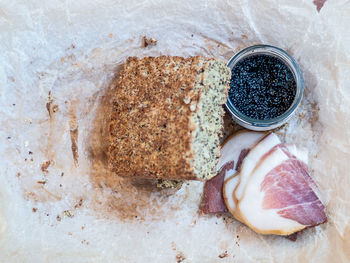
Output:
[226,45,303,131]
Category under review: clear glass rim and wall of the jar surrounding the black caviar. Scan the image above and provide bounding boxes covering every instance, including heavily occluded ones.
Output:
[225,45,304,131]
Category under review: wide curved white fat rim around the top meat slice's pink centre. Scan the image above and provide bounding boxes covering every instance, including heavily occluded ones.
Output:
[236,147,305,235]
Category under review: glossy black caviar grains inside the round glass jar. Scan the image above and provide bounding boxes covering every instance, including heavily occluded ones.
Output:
[229,55,296,120]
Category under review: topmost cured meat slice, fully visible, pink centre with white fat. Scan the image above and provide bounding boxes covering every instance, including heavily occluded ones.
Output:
[236,145,327,235]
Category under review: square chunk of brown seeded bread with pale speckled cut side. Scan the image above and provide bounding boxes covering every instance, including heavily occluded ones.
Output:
[109,56,231,180]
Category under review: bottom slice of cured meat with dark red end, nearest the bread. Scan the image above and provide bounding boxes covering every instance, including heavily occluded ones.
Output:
[201,130,265,214]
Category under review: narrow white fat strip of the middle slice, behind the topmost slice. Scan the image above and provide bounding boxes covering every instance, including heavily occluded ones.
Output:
[234,133,281,200]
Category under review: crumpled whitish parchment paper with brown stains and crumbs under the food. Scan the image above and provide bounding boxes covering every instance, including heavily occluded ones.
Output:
[0,0,350,262]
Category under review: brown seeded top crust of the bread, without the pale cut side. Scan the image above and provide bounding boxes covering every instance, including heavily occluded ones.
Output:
[109,56,229,180]
